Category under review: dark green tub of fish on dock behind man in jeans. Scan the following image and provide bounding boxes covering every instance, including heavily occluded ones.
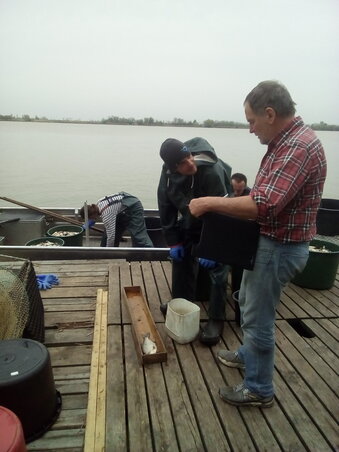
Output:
[292,240,339,290]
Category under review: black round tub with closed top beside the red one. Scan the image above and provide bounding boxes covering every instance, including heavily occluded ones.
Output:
[0,339,61,442]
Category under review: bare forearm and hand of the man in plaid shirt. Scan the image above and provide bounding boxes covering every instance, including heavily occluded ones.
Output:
[189,196,258,220]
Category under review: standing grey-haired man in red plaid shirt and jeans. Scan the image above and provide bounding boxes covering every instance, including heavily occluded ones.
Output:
[189,81,326,407]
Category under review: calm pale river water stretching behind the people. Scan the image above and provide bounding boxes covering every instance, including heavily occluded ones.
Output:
[0,121,339,209]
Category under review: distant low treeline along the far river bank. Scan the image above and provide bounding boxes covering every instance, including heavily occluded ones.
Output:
[0,115,339,131]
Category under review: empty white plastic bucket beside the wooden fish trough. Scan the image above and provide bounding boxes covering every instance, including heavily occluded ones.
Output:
[165,298,200,344]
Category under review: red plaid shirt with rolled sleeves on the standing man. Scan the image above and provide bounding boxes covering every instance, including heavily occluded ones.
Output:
[250,117,327,243]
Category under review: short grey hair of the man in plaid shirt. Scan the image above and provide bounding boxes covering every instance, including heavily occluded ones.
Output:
[244,80,296,118]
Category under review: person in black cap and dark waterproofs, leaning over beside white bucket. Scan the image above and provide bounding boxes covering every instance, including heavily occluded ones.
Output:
[158,137,232,345]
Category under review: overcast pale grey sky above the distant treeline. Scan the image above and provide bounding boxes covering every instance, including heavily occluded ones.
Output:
[0,0,339,124]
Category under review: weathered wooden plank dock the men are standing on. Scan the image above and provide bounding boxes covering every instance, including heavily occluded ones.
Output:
[27,260,339,452]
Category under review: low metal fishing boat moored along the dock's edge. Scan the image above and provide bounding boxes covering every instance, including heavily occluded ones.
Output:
[0,206,168,261]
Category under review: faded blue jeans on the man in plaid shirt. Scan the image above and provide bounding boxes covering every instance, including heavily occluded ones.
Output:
[238,236,309,397]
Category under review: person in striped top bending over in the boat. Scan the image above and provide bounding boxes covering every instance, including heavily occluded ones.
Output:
[79,191,153,248]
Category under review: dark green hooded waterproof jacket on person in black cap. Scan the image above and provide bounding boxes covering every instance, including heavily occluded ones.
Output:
[158,137,232,246]
